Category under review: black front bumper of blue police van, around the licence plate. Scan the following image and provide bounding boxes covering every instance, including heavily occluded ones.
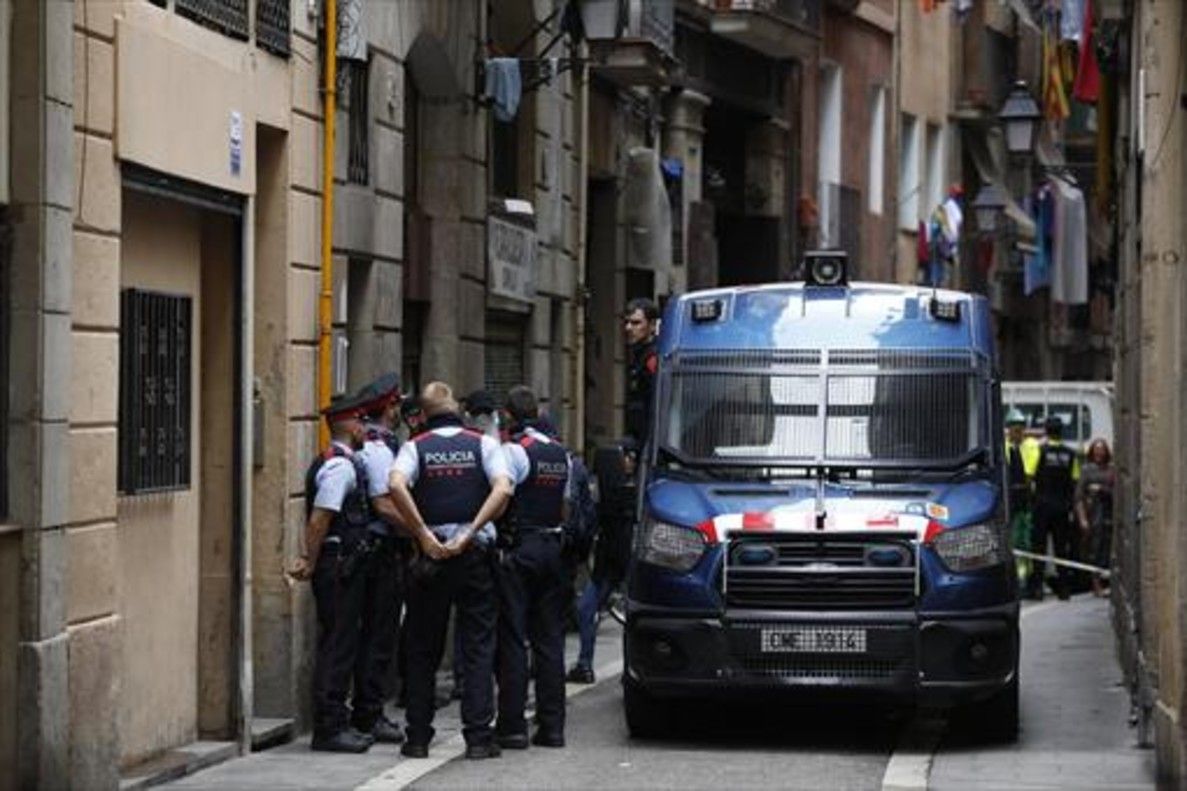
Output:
[623,602,1018,707]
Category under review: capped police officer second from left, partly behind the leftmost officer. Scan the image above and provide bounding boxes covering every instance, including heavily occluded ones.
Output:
[353,373,408,743]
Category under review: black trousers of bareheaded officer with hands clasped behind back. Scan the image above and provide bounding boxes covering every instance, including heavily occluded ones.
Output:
[404,545,497,745]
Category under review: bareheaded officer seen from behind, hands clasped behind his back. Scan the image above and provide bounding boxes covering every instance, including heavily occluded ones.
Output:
[391,382,513,759]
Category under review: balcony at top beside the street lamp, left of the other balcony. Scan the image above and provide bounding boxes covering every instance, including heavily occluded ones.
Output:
[582,0,675,87]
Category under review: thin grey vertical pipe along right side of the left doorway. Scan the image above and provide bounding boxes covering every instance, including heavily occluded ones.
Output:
[235,195,255,755]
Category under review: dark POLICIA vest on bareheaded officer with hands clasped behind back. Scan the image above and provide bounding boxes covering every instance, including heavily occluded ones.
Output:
[412,429,490,525]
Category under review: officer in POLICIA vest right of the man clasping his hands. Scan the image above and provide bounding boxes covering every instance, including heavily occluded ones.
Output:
[496,386,572,749]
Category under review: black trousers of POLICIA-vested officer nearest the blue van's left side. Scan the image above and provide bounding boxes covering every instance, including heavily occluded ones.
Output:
[499,531,571,736]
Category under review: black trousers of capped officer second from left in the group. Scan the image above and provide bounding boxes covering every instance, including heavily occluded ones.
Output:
[351,538,404,732]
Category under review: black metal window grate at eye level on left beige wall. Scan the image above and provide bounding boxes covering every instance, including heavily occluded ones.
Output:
[119,289,192,494]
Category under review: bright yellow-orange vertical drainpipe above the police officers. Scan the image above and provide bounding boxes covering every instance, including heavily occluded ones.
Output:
[317,0,338,448]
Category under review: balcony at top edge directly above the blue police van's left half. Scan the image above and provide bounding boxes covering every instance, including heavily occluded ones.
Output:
[697,0,820,58]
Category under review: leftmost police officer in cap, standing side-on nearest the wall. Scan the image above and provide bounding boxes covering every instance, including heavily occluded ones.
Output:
[290,399,374,753]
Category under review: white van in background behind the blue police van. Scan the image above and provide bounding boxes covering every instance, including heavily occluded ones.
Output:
[1002,381,1113,451]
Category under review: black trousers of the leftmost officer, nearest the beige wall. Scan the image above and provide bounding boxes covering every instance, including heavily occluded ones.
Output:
[312,543,366,736]
